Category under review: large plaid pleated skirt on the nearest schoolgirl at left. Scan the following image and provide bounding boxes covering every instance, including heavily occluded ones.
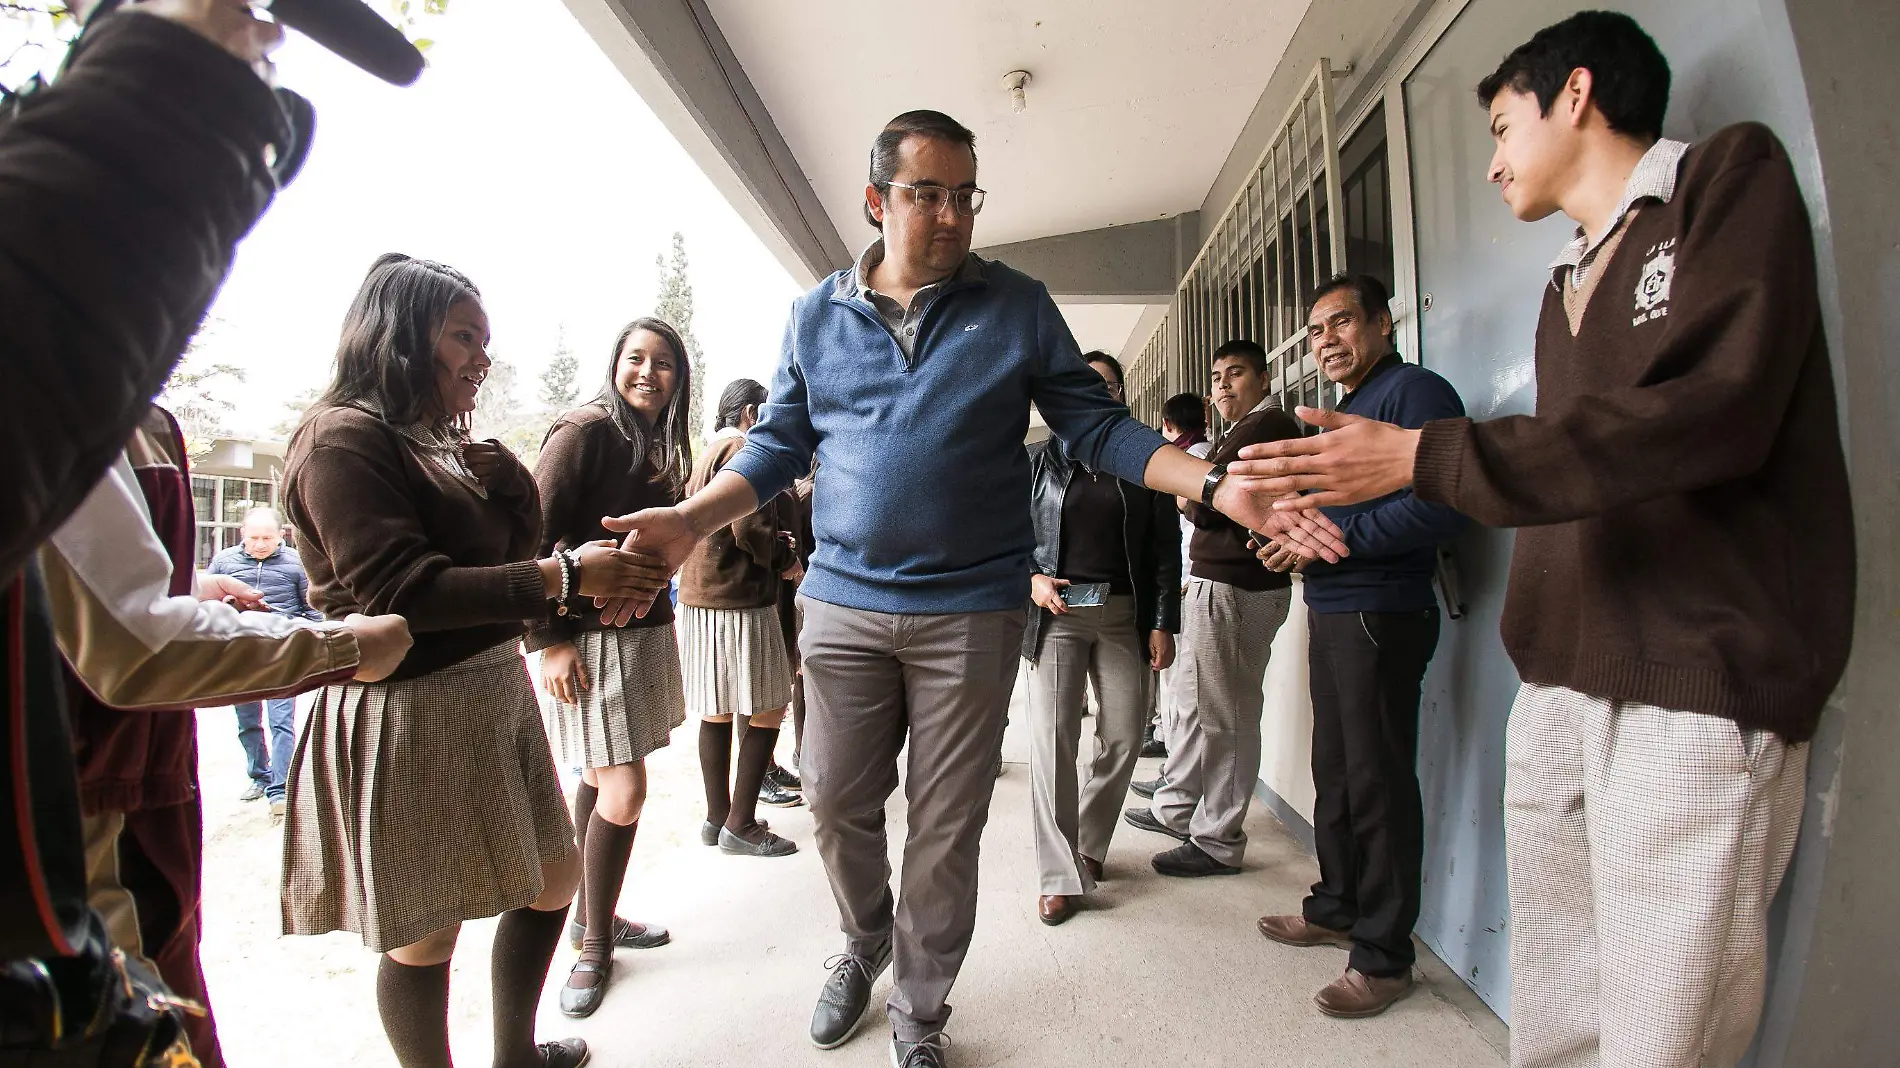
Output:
[283,642,574,952]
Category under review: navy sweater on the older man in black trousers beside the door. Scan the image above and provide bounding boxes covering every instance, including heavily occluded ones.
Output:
[1303,353,1465,612]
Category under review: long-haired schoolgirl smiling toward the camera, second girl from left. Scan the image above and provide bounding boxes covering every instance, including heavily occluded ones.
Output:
[528,319,694,1017]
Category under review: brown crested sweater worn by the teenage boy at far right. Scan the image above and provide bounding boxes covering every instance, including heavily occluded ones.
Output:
[1416,124,1854,741]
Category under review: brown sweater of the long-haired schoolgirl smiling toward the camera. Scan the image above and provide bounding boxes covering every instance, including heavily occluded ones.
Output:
[526,403,680,652]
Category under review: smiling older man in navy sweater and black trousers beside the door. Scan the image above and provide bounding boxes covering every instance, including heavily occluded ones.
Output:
[1260,276,1465,1017]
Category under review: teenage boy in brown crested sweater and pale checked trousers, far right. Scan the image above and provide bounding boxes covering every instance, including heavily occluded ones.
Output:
[1231,11,1854,1068]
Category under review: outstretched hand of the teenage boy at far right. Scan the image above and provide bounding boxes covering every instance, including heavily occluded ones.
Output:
[1222,407,1419,509]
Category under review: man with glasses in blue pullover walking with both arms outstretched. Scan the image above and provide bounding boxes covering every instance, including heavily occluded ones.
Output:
[606,112,1343,1068]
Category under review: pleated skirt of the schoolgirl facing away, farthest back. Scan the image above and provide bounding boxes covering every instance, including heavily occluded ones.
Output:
[678,604,792,718]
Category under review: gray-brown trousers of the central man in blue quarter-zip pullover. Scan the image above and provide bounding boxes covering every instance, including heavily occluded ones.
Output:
[798,597,1022,1041]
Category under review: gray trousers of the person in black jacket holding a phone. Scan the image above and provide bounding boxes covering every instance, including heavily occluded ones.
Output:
[1030,597,1153,895]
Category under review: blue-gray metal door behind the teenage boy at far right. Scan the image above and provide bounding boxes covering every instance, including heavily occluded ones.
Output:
[1404,0,1824,1015]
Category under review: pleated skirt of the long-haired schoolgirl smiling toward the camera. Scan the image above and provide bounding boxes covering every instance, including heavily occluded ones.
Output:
[547,627,686,768]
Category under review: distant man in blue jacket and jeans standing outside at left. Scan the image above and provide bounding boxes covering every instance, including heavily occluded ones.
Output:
[205,507,323,823]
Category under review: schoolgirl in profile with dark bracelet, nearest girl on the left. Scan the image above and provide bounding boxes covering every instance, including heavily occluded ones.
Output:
[283,255,665,1068]
